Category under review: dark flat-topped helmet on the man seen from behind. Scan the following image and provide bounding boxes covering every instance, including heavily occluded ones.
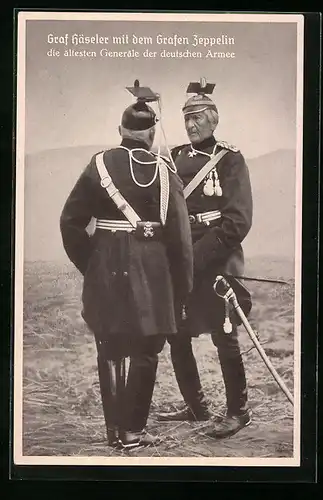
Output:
[121,80,159,130]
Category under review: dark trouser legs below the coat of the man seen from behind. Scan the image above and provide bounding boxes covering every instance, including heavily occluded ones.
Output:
[97,335,166,432]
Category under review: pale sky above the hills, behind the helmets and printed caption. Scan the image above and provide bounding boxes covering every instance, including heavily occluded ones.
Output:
[24,20,297,158]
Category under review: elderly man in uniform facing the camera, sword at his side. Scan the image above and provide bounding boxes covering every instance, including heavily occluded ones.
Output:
[159,79,253,438]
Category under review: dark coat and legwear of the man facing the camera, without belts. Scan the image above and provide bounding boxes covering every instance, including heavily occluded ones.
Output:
[164,136,252,419]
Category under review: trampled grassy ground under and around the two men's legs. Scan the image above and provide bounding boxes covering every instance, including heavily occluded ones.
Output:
[23,263,294,457]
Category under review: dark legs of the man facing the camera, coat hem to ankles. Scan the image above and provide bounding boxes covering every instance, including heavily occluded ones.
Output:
[168,325,248,415]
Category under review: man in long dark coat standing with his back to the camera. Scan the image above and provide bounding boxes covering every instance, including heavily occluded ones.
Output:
[60,82,193,447]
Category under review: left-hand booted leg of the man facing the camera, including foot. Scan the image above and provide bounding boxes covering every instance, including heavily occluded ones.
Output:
[157,335,210,421]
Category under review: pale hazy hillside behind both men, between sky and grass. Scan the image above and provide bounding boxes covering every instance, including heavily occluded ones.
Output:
[20,145,295,280]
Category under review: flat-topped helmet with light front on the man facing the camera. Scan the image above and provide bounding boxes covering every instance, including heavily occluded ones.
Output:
[182,78,218,116]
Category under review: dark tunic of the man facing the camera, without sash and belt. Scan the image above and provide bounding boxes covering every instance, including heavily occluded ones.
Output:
[172,137,253,336]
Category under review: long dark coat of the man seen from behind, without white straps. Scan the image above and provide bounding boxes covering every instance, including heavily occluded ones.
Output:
[60,140,193,340]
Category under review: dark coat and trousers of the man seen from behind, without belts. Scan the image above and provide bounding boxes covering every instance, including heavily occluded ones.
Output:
[60,139,193,442]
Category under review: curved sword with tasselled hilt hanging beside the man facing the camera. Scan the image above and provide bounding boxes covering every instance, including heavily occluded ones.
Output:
[213,276,294,406]
